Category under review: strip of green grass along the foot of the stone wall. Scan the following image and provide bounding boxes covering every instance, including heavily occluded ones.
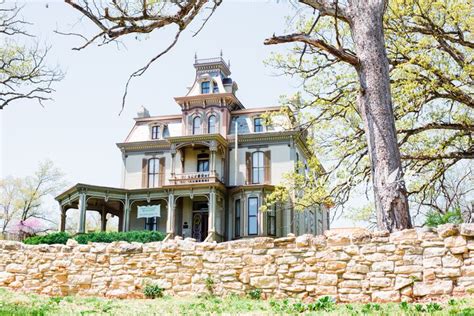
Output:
[0,289,474,316]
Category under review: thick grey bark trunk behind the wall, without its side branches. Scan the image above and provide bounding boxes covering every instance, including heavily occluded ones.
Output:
[349,0,412,231]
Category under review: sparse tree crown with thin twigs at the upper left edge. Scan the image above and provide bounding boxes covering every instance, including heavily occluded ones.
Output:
[0,1,63,110]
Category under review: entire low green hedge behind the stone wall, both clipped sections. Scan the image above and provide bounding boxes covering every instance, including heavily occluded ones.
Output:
[23,230,165,245]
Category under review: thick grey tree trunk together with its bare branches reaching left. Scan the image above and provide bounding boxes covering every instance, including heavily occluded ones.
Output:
[265,0,412,231]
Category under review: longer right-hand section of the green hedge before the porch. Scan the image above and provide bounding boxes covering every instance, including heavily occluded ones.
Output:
[74,230,165,244]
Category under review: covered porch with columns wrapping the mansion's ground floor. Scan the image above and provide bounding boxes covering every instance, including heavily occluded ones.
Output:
[56,182,225,241]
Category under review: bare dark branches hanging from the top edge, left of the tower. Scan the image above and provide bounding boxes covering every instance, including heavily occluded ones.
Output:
[62,0,222,110]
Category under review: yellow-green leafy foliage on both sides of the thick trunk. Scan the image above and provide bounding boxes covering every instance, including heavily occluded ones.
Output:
[264,0,474,225]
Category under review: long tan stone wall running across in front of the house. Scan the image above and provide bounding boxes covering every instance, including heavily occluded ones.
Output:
[0,224,474,302]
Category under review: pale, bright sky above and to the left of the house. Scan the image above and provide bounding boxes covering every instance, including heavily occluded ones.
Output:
[0,0,358,227]
